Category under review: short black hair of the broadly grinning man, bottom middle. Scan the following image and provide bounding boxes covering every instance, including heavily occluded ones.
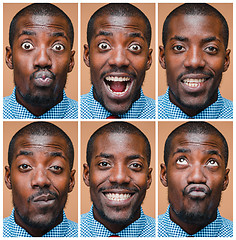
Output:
[86,121,151,166]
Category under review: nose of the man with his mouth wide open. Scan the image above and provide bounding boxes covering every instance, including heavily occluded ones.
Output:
[108,46,129,68]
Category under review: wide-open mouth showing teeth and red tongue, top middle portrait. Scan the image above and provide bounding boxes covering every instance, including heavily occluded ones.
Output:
[104,76,133,96]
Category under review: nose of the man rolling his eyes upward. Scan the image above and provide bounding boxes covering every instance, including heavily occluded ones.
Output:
[187,164,206,184]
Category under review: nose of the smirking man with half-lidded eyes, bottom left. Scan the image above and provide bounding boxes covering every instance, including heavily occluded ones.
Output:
[31,167,51,188]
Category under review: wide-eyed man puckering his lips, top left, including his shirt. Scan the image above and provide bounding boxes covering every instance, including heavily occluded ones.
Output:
[3,3,78,119]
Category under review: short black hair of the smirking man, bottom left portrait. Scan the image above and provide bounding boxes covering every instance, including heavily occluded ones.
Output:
[8,121,74,170]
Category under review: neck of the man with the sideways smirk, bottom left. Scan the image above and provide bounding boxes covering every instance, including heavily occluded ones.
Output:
[14,211,63,237]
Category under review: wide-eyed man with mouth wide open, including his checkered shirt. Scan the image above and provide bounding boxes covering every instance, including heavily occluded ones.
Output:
[81,3,155,119]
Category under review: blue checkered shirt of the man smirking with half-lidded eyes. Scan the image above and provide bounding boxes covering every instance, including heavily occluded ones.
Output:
[3,209,78,237]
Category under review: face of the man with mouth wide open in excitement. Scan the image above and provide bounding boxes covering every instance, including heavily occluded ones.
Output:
[84,15,152,114]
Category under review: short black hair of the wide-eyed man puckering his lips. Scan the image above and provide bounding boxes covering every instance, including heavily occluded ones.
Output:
[9,3,74,49]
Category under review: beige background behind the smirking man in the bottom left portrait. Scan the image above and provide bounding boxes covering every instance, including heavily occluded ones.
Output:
[3,121,78,222]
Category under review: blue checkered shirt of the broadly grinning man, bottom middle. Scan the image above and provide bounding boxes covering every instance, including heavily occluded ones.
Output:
[80,207,156,237]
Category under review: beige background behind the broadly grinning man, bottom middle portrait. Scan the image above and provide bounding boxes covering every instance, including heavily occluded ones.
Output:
[80,121,156,217]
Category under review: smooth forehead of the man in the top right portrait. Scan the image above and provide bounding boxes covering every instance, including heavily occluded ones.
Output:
[167,14,223,40]
